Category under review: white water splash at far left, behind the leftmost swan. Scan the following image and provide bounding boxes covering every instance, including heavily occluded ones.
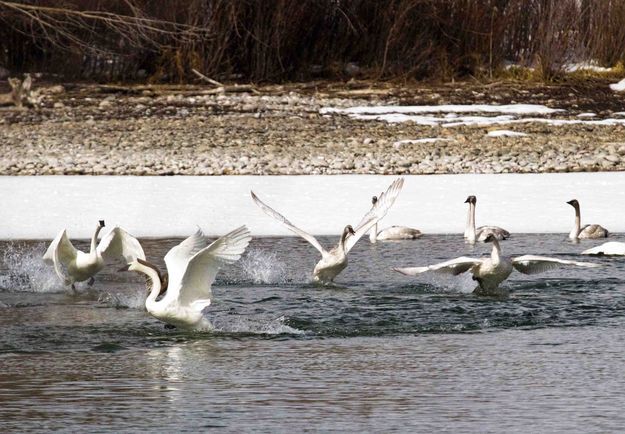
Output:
[0,243,65,292]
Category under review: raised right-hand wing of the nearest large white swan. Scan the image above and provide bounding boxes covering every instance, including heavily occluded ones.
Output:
[172,226,252,309]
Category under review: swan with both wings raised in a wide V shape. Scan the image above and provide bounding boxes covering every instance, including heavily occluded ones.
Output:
[251,178,404,285]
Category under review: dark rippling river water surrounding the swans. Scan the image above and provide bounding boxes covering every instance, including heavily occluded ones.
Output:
[0,234,625,432]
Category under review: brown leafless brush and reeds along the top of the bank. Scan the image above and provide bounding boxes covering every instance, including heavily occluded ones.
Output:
[0,0,625,82]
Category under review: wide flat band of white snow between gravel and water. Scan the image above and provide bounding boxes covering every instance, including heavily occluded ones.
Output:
[0,172,625,239]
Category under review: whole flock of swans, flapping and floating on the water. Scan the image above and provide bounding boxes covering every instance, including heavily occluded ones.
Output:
[43,178,625,330]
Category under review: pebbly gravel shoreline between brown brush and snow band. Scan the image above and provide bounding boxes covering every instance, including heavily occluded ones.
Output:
[0,80,625,175]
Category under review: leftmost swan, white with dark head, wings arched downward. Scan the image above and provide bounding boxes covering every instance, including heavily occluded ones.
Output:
[43,220,145,291]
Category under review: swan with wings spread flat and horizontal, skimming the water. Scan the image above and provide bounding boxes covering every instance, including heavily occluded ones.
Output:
[393,234,599,295]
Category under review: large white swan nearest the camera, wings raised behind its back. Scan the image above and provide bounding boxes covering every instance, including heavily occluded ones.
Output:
[120,226,252,330]
